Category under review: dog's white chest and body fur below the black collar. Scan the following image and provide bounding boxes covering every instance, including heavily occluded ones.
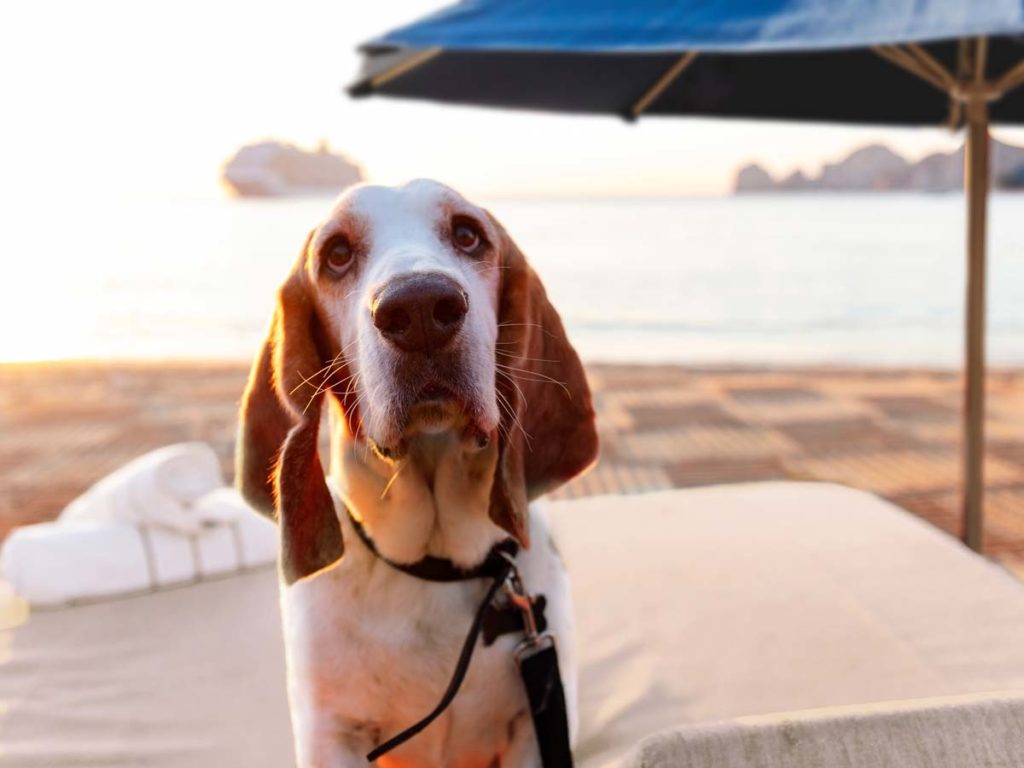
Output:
[282,511,575,768]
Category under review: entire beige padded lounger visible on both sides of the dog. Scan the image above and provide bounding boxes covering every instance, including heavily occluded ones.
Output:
[0,483,1024,768]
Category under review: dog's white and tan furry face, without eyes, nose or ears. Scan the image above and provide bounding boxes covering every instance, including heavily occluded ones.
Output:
[310,180,499,451]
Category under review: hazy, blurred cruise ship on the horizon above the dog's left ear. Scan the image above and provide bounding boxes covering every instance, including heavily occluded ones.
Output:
[221,141,362,197]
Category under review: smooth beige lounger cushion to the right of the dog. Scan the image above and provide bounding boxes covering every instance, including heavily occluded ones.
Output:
[551,482,1024,768]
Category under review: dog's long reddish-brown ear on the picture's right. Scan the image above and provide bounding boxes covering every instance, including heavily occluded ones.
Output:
[490,222,598,546]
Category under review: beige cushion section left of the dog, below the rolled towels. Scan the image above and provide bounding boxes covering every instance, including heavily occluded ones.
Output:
[0,568,294,768]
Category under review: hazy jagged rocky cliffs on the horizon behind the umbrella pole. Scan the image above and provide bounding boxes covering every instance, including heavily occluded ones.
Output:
[733,141,1024,193]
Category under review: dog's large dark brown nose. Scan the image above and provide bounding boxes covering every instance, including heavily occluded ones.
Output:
[373,272,469,352]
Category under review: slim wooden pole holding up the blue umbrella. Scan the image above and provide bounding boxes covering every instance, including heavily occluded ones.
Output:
[963,94,989,552]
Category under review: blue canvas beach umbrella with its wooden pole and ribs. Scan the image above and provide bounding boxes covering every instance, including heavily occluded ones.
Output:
[349,0,1024,550]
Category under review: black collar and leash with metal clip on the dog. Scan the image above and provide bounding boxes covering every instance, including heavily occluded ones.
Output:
[348,512,572,768]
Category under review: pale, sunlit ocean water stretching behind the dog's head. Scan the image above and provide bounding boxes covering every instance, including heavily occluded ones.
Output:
[0,194,1024,367]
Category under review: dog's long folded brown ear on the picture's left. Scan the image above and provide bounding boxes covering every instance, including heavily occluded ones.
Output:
[234,241,344,584]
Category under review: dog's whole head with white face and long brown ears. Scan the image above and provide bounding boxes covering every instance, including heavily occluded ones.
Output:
[237,181,597,583]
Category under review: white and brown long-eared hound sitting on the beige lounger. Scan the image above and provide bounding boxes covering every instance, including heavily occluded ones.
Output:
[237,180,598,768]
